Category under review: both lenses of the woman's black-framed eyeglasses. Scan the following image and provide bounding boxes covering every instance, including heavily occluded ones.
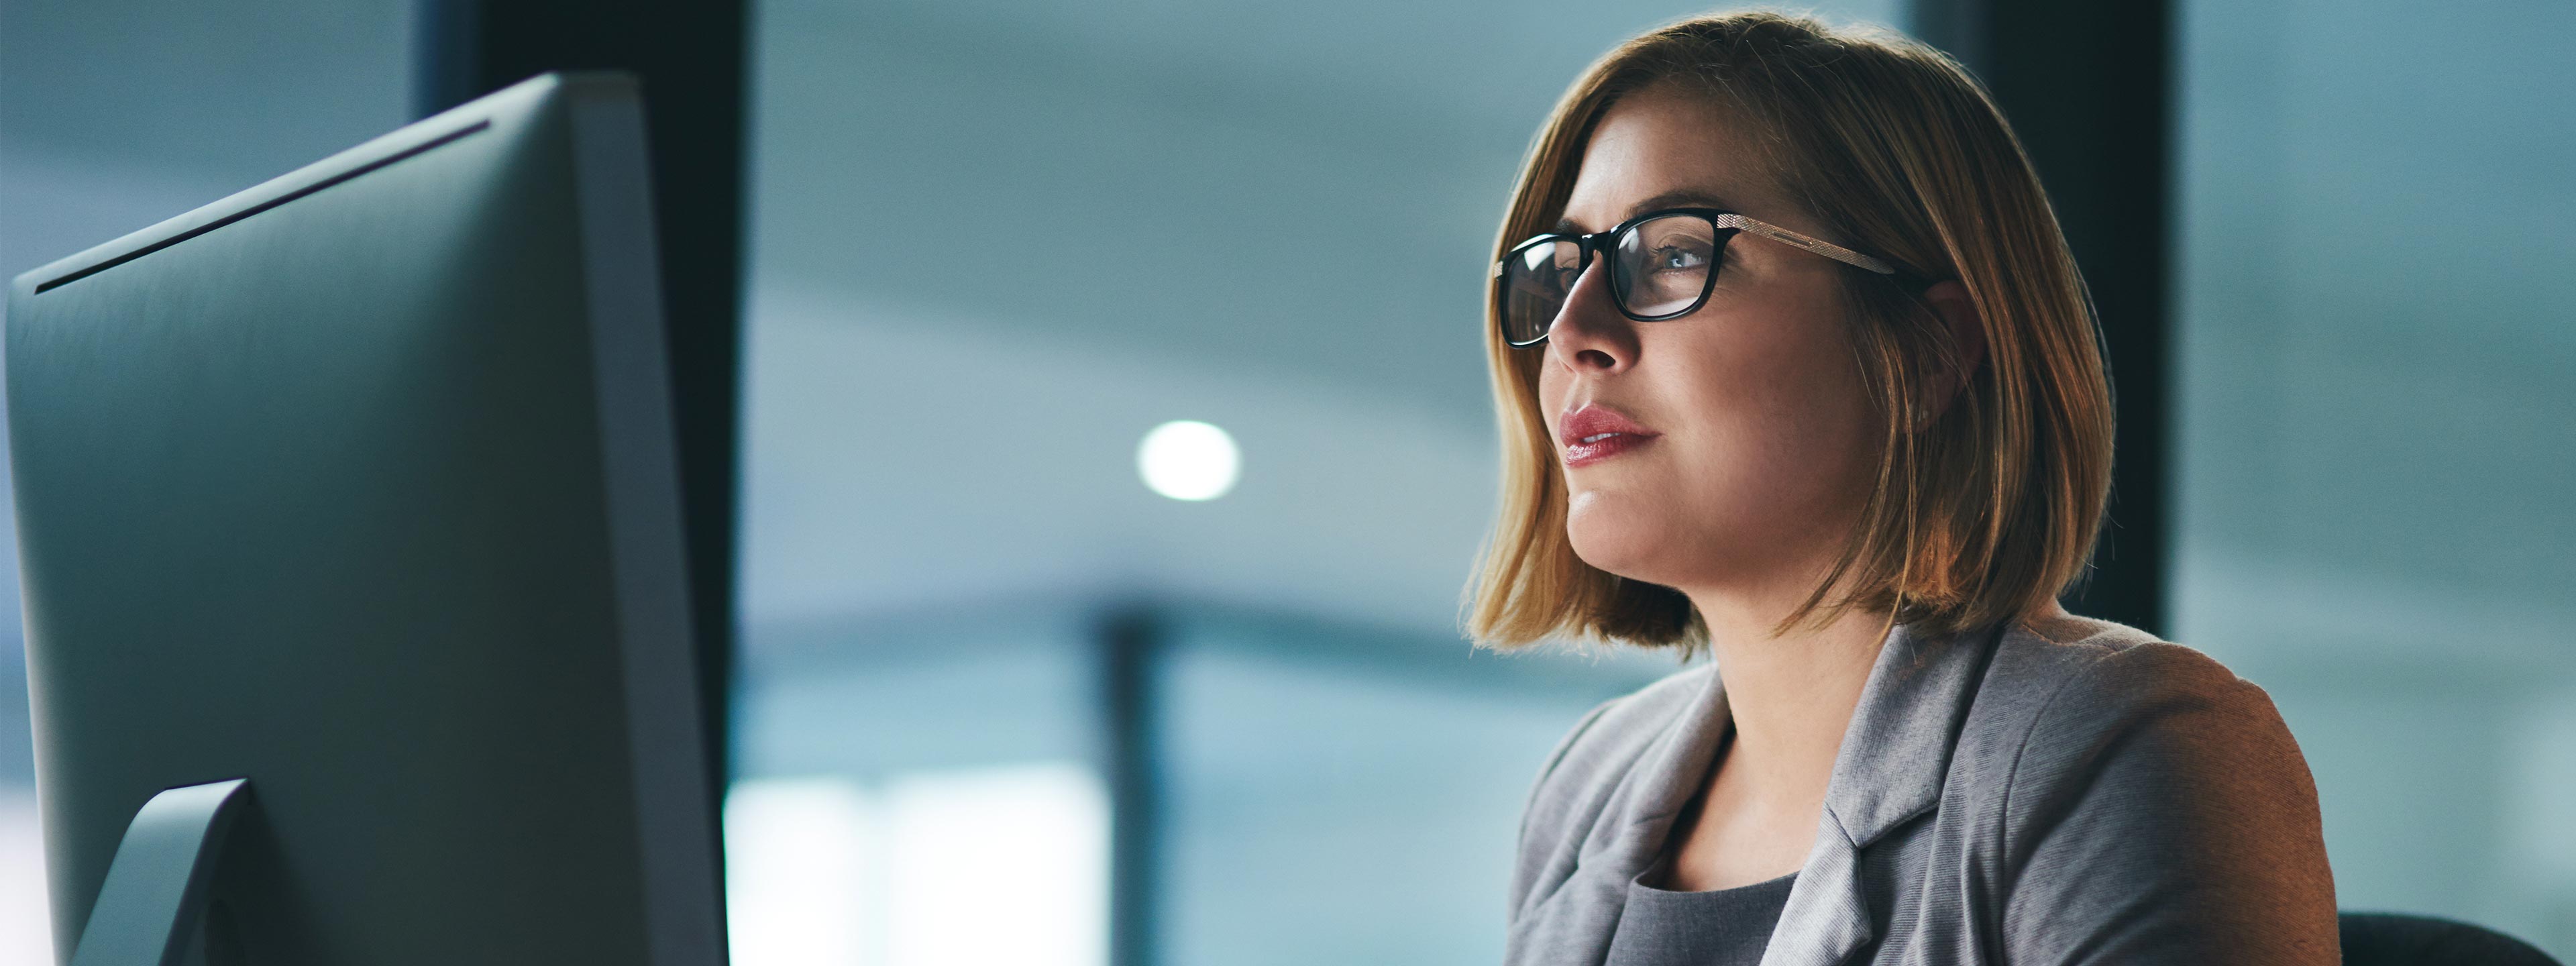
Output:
[1502,214,1733,345]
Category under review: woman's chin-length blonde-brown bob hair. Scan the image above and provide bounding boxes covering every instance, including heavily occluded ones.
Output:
[1466,13,2112,652]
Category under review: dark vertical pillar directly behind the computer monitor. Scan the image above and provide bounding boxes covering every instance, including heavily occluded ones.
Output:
[415,0,747,855]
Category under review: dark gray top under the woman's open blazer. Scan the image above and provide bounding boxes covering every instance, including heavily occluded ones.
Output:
[1610,863,1798,966]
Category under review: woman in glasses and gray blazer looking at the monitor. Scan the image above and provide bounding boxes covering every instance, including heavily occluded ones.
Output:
[1471,13,2339,966]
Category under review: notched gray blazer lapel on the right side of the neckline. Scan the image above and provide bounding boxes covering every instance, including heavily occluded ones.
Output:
[1762,626,2002,966]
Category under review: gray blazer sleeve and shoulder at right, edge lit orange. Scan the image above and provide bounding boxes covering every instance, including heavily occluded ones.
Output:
[1955,619,2334,963]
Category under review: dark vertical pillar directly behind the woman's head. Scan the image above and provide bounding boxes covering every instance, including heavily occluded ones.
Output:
[1914,0,2177,634]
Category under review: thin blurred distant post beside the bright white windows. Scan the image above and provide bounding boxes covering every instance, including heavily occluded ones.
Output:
[1095,608,1165,966]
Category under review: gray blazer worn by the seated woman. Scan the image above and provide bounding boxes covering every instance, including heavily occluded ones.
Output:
[1505,616,2342,966]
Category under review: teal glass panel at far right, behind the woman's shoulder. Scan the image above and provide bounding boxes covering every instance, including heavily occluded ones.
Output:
[2174,0,2576,958]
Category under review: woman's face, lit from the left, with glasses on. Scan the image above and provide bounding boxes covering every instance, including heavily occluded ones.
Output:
[1538,85,1883,598]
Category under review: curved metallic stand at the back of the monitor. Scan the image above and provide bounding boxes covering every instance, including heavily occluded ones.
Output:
[72,778,250,966]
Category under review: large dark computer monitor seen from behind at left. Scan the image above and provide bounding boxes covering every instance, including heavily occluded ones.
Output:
[8,74,724,966]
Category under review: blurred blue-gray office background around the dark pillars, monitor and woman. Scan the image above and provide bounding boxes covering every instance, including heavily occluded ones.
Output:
[0,0,2576,966]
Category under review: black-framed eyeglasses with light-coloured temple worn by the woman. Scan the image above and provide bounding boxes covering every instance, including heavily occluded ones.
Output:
[1494,209,1896,347]
